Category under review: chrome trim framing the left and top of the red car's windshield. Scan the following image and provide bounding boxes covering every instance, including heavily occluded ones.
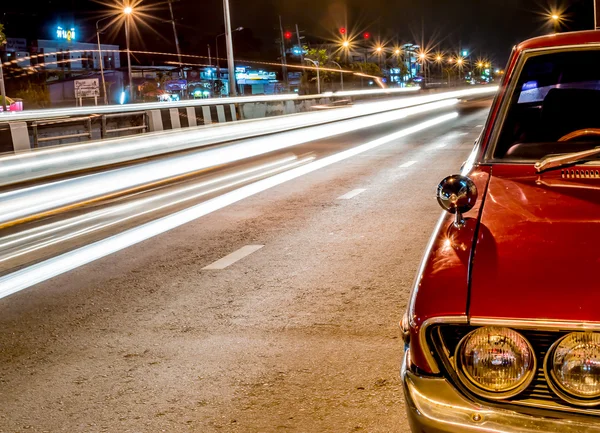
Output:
[481,43,600,164]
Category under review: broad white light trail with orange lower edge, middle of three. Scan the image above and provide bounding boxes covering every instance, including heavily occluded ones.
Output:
[0,99,458,227]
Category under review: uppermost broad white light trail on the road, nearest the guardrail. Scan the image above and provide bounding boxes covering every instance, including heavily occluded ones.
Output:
[0,86,497,186]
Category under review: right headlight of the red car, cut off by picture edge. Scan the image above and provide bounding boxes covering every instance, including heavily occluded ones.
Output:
[545,332,600,406]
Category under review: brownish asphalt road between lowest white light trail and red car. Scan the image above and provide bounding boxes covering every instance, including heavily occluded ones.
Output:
[0,102,489,433]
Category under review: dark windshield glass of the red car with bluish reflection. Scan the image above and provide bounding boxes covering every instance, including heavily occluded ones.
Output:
[494,49,600,161]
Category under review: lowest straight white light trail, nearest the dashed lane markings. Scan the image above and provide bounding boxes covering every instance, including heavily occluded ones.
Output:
[0,112,459,298]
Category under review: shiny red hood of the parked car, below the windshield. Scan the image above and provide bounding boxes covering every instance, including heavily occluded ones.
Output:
[468,166,600,321]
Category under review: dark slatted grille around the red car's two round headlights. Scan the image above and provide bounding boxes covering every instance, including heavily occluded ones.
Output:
[432,325,600,415]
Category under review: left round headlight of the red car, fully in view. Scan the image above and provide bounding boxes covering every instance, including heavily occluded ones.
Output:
[455,327,536,399]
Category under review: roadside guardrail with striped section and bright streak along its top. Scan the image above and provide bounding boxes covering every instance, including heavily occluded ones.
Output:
[0,87,420,152]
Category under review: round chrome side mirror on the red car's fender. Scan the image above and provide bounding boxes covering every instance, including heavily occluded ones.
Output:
[437,174,477,227]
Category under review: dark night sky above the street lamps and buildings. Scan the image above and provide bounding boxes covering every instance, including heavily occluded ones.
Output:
[1,0,593,64]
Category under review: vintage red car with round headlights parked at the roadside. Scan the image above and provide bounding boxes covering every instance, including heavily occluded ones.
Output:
[402,31,600,433]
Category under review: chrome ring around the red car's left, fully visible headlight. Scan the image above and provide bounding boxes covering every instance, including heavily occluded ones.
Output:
[454,326,537,400]
